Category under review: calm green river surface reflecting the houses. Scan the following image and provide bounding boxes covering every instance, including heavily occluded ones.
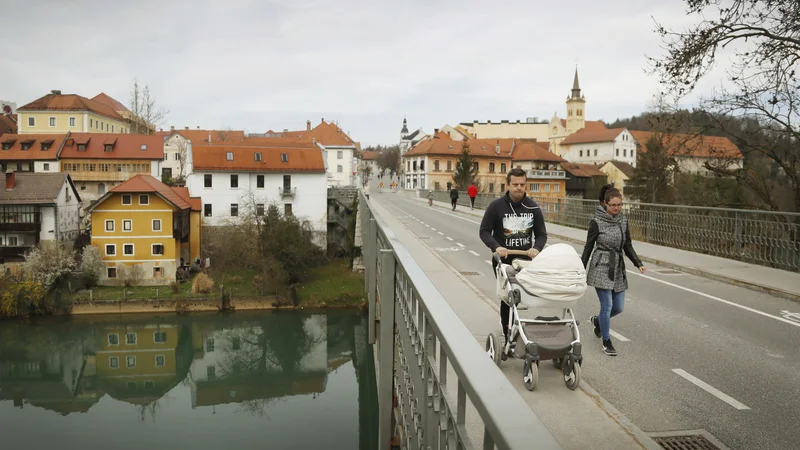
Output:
[0,312,377,449]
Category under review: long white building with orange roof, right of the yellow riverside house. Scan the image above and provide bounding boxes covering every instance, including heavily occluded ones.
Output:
[186,145,328,244]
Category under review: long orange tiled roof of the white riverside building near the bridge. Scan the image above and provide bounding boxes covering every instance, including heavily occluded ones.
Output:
[192,145,325,173]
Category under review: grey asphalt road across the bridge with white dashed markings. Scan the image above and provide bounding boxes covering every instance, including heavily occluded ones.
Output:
[371,181,800,450]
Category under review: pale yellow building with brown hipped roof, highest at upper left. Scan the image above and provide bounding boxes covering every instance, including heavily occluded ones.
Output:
[17,90,130,134]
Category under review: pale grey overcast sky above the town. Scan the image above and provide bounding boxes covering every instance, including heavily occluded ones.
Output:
[0,0,728,145]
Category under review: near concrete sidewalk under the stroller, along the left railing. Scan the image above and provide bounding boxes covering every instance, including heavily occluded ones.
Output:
[370,194,661,450]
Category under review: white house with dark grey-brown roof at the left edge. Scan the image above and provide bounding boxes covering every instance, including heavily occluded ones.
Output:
[0,172,81,262]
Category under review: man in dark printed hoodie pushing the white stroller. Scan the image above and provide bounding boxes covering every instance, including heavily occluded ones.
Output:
[480,167,547,346]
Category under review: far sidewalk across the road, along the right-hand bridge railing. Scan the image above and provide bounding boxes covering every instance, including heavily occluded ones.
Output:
[401,191,800,302]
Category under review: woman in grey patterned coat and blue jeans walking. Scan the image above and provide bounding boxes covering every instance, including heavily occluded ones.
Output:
[581,184,646,356]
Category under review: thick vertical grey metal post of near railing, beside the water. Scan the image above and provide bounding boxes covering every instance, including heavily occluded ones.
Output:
[373,249,395,448]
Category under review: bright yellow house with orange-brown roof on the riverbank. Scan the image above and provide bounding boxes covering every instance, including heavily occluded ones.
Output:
[89,175,201,285]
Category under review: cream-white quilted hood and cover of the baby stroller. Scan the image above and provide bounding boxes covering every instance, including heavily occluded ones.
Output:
[514,244,586,302]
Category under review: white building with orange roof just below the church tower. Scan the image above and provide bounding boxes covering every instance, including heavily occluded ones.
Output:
[561,128,636,167]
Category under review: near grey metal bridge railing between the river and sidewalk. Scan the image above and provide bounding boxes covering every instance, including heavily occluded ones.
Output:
[359,193,561,450]
